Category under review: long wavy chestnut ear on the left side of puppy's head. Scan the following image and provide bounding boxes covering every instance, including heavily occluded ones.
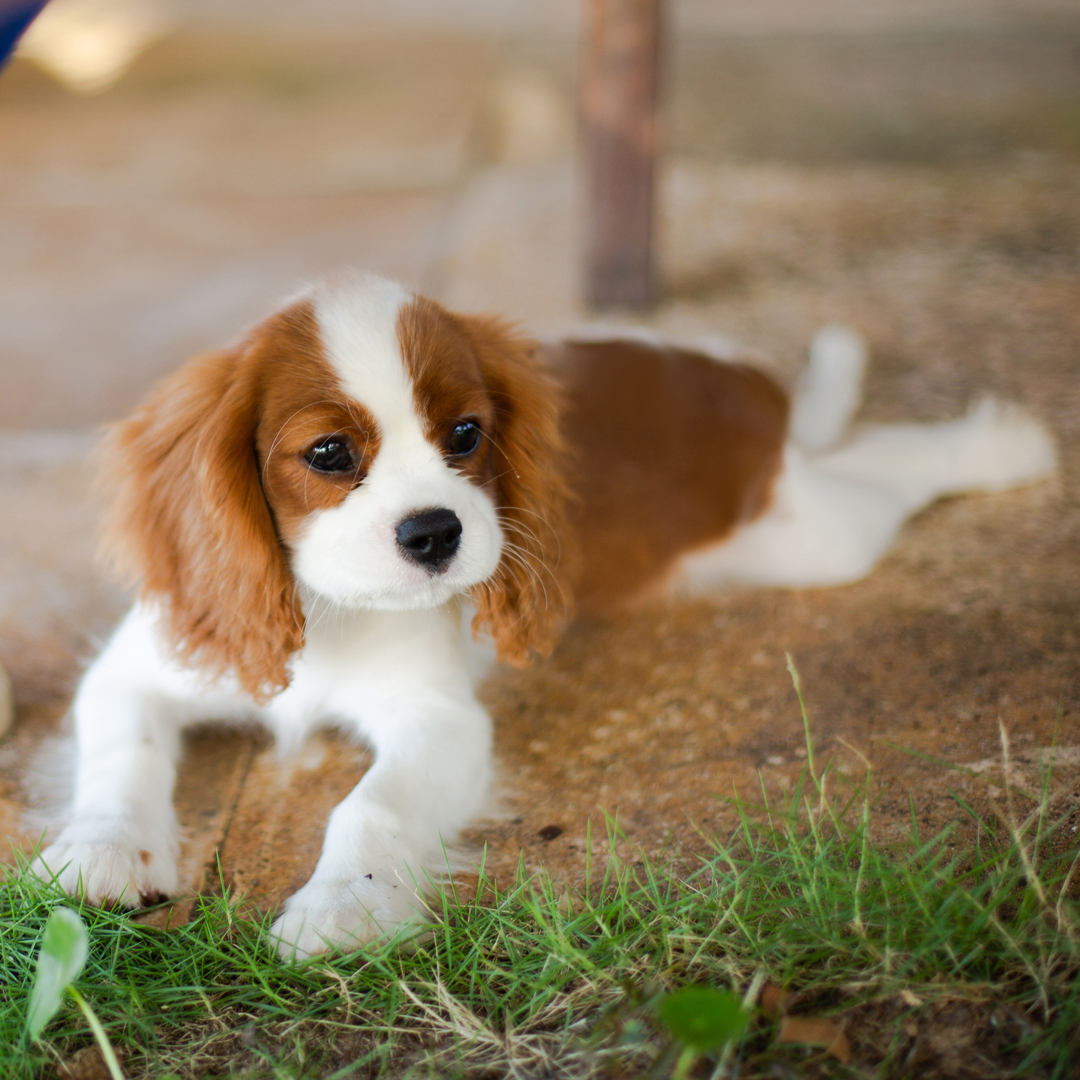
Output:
[98,321,303,701]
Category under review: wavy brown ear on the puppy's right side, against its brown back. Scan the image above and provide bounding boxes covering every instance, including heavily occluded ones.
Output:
[460,318,577,666]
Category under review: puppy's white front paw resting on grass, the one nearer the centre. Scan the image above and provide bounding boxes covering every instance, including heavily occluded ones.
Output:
[270,876,423,960]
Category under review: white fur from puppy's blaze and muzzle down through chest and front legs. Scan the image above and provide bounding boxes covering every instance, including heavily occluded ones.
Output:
[37,278,502,957]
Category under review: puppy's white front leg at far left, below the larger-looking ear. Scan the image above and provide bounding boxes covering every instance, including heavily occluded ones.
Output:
[31,609,180,907]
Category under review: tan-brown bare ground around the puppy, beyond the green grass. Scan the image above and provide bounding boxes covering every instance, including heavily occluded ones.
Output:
[0,5,1080,917]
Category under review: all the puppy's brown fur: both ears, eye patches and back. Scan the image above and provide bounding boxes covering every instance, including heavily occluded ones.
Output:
[103,287,787,701]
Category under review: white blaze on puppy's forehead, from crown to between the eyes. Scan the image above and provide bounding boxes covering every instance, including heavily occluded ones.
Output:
[314,274,418,436]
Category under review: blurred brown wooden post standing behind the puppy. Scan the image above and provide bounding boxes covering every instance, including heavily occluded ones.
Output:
[579,0,660,308]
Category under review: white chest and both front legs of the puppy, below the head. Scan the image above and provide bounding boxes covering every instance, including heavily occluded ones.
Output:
[39,603,491,958]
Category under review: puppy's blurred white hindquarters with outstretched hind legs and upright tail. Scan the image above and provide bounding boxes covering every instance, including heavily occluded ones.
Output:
[672,349,1056,594]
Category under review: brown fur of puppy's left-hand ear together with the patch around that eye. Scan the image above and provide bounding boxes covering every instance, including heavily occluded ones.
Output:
[100,301,367,701]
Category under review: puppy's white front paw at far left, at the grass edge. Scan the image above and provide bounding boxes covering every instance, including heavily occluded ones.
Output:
[30,819,179,907]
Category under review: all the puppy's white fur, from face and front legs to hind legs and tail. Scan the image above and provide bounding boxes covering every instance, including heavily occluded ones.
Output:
[36,289,1053,958]
